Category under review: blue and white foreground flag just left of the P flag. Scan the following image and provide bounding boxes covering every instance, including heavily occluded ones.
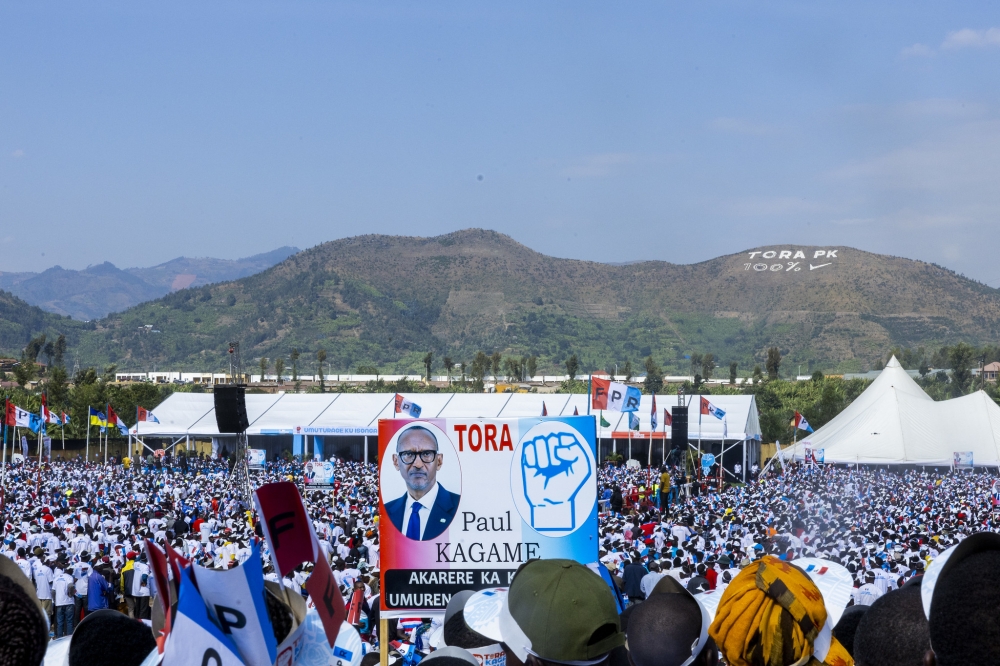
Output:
[163,567,245,666]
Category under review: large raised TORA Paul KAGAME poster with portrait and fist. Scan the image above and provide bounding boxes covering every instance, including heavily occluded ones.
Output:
[379,416,598,616]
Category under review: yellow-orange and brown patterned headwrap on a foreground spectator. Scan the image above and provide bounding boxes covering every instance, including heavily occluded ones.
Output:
[708,555,854,666]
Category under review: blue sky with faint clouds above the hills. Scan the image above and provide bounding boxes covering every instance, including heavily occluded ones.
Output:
[0,0,1000,286]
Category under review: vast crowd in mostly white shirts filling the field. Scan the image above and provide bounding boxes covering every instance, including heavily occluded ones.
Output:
[0,456,1000,666]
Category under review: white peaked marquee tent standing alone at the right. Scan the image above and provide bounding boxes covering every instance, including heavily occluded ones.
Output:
[783,357,1000,465]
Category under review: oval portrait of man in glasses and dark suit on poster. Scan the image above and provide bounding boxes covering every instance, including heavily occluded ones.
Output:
[382,425,461,541]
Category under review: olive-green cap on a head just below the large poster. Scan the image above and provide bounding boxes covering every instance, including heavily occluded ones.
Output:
[500,560,625,666]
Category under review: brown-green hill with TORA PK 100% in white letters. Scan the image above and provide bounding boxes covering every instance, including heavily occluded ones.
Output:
[35,229,1000,374]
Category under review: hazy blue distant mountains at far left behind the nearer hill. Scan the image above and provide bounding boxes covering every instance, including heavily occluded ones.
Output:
[0,247,299,321]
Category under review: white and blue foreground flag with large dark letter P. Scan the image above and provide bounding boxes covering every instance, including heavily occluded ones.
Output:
[191,544,278,666]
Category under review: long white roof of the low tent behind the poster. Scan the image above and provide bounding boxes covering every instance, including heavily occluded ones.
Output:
[138,393,760,440]
